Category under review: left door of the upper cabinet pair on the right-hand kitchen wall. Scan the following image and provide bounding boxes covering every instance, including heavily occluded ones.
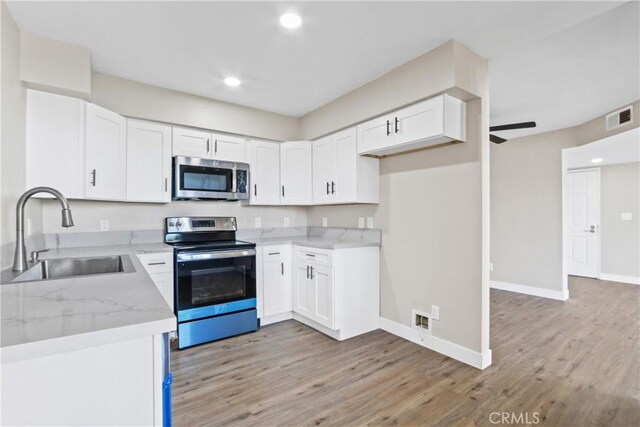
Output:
[313,135,336,203]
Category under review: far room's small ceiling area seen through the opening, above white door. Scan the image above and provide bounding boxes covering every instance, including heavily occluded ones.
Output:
[565,128,640,169]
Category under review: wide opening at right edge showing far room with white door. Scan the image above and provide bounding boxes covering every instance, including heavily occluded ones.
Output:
[562,128,640,295]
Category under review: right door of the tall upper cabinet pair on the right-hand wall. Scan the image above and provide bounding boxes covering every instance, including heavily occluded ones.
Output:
[331,127,359,203]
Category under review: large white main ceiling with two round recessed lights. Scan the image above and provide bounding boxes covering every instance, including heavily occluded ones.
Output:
[8,1,640,138]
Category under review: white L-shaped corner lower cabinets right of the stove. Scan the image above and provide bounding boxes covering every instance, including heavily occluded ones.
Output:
[258,245,380,340]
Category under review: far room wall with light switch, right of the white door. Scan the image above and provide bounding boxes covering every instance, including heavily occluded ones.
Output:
[600,162,640,278]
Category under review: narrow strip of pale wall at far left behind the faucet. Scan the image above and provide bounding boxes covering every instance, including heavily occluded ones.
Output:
[0,2,42,244]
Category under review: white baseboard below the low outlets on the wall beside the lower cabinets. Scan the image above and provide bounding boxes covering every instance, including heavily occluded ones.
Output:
[380,317,491,369]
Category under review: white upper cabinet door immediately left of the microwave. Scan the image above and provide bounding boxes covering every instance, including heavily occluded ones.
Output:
[127,119,171,203]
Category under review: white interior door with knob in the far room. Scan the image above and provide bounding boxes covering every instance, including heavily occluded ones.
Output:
[567,170,600,277]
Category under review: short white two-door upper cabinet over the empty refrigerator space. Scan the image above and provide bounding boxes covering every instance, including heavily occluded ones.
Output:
[357,95,466,156]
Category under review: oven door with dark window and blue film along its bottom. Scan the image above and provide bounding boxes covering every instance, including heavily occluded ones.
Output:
[175,249,256,322]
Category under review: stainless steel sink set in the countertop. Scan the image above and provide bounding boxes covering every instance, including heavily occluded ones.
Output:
[12,255,136,282]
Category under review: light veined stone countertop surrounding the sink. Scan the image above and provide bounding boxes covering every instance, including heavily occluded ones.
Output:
[0,243,176,364]
